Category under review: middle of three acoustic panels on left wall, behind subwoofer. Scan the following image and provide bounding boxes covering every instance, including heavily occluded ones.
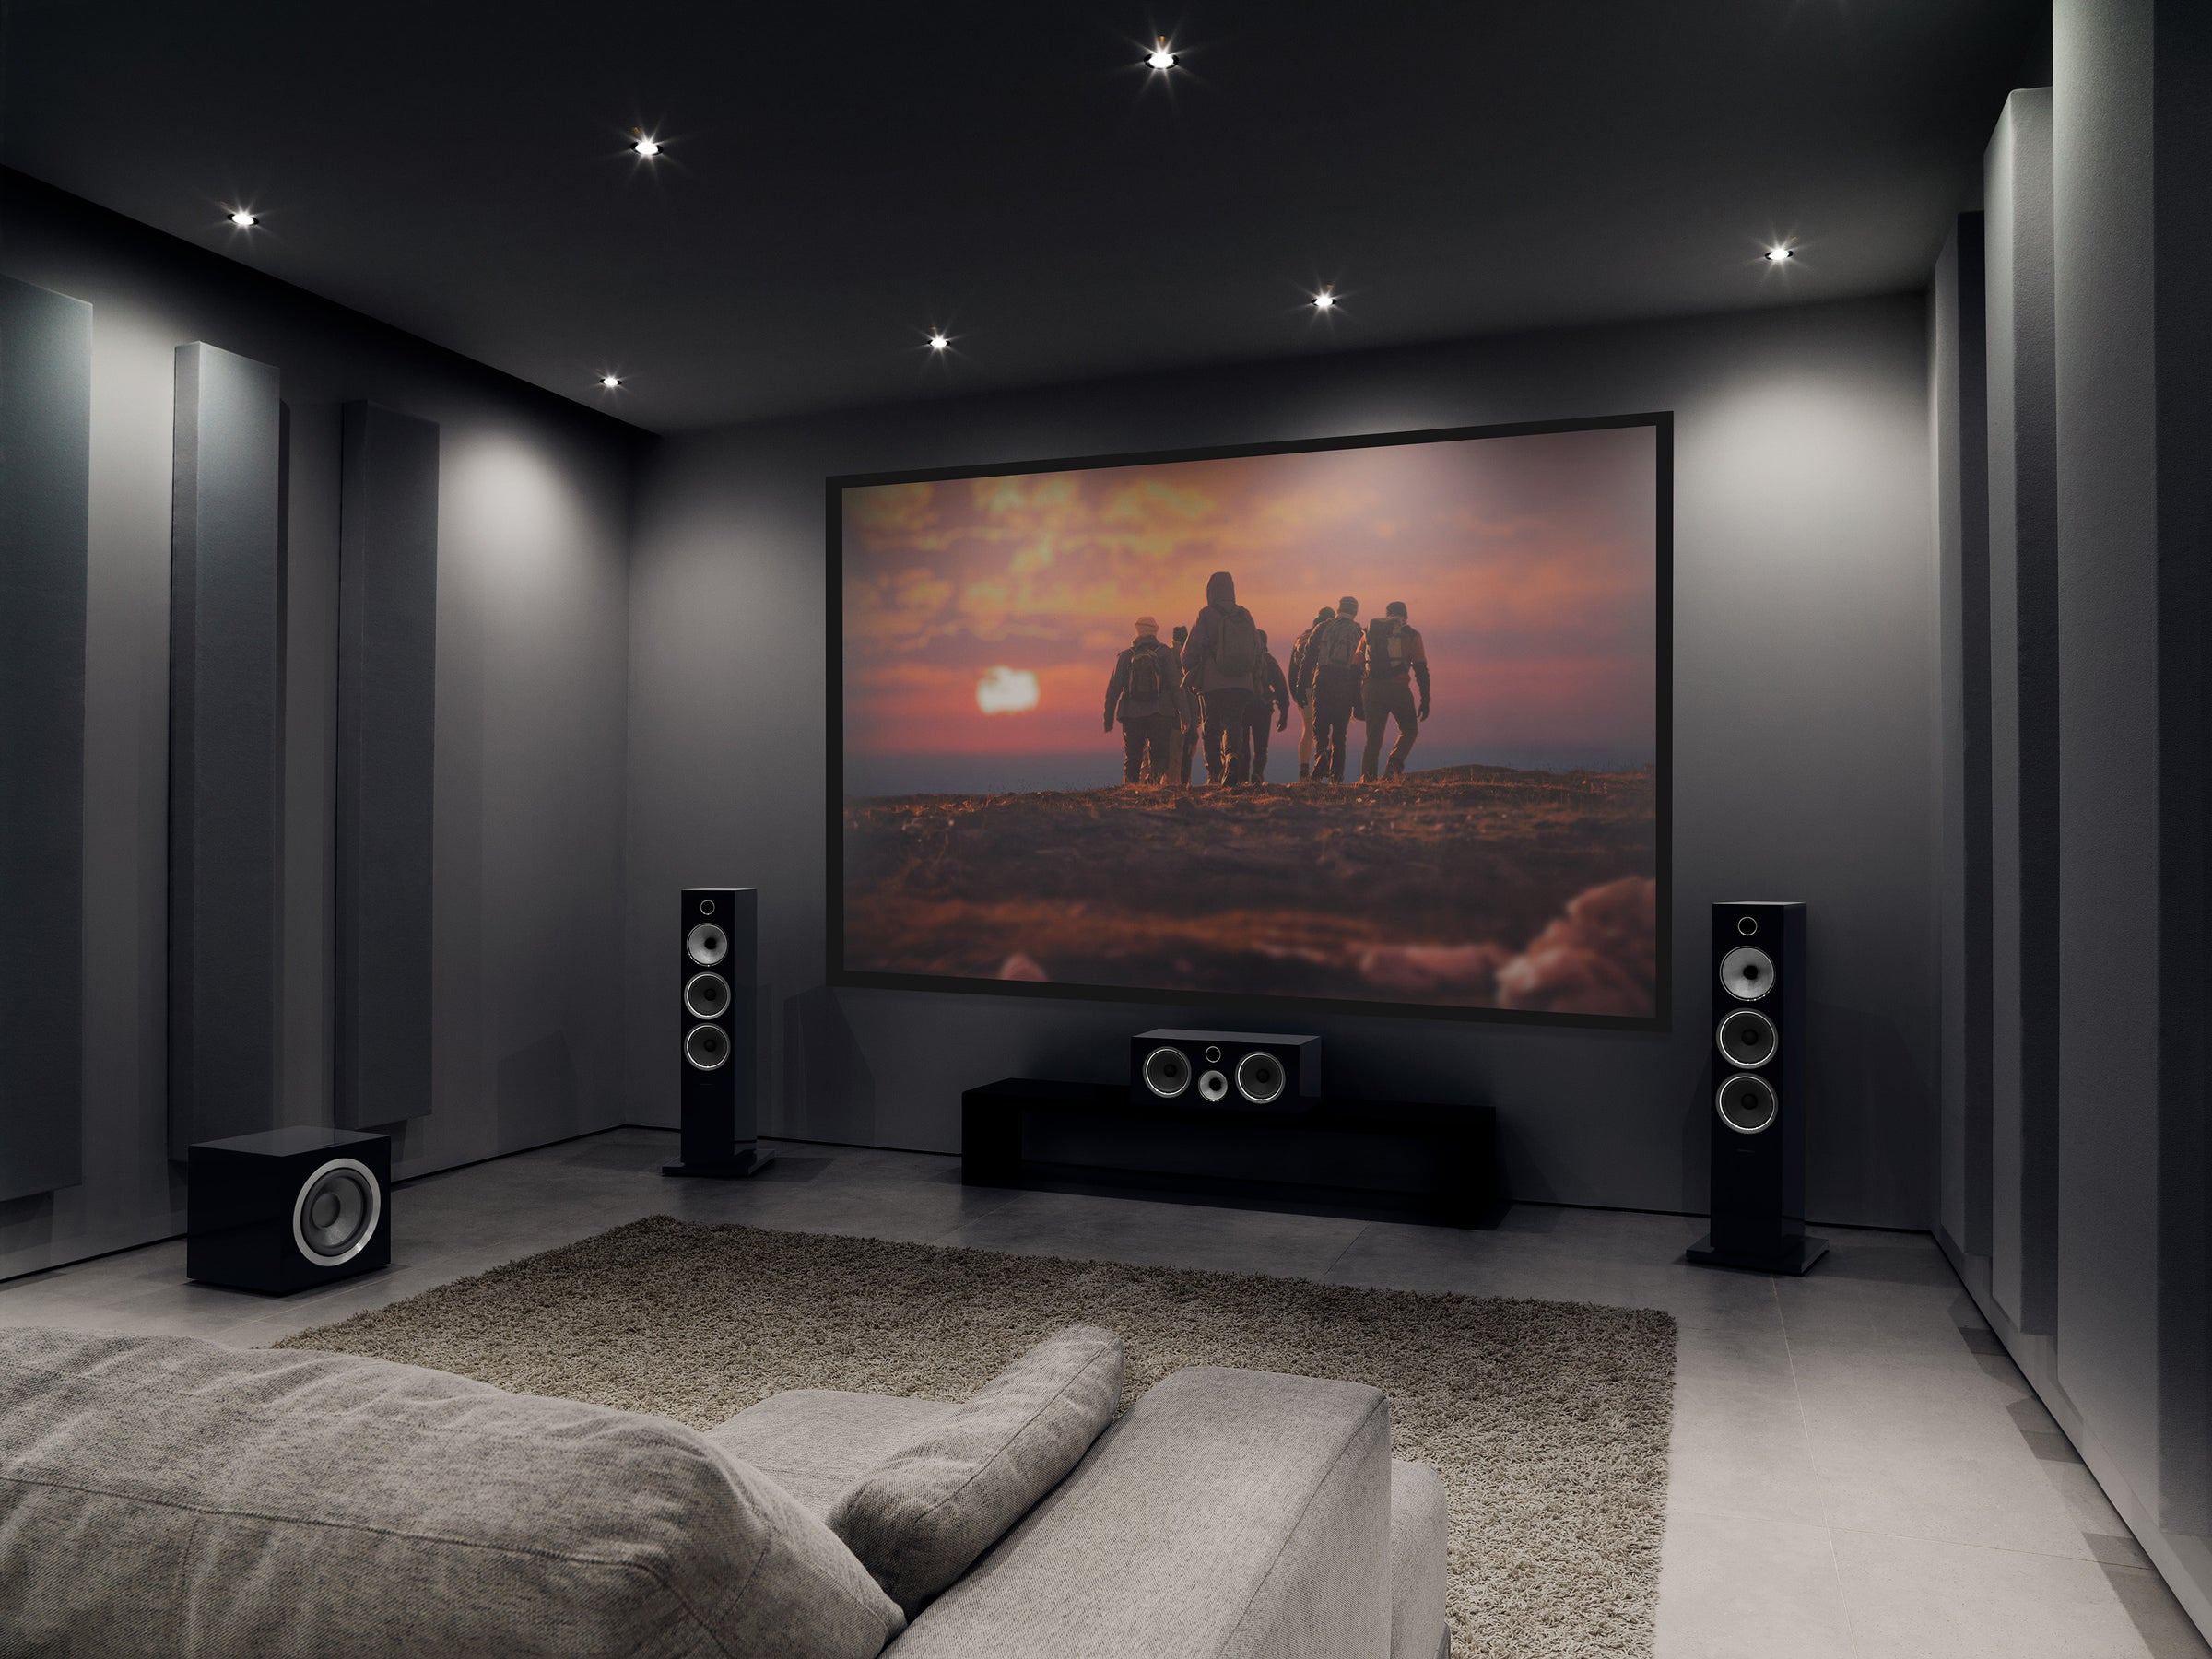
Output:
[168,343,283,1159]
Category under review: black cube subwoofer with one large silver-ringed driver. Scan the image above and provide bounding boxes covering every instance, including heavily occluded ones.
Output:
[183,1128,392,1294]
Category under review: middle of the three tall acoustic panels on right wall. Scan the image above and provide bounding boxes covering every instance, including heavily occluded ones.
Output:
[1982,88,2059,1334]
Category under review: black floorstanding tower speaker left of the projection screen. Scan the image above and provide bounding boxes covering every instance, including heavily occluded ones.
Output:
[662,887,774,1179]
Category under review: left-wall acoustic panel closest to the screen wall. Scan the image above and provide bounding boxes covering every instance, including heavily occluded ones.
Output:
[336,403,438,1128]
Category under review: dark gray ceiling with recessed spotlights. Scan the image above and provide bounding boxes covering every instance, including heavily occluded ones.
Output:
[0,0,2048,431]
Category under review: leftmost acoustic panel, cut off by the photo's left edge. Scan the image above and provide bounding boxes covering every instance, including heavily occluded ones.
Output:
[0,276,93,1199]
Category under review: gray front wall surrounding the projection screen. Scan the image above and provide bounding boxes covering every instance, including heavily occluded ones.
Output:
[624,294,1937,1226]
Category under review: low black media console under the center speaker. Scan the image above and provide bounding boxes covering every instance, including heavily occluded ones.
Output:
[960,1077,1498,1228]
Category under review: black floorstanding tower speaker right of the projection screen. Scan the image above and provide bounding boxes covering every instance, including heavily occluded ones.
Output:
[1688,902,1827,1274]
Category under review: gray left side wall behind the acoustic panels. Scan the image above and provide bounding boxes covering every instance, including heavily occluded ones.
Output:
[0,172,637,1274]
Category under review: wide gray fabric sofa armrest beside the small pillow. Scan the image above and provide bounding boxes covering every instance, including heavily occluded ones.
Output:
[885,1367,1392,1659]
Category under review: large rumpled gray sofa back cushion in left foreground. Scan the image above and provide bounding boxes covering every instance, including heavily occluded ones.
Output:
[0,1329,905,1659]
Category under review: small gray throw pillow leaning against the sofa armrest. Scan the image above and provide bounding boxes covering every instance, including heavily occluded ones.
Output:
[828,1325,1122,1617]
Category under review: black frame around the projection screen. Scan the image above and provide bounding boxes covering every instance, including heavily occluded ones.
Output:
[823,411,1675,1030]
